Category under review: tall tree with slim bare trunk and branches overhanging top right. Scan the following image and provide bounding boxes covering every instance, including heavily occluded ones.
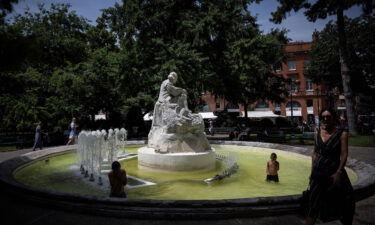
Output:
[271,0,375,134]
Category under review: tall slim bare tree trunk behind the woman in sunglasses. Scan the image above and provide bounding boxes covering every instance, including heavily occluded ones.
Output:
[337,9,358,135]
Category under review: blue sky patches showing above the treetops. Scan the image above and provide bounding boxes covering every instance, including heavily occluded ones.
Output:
[10,0,361,41]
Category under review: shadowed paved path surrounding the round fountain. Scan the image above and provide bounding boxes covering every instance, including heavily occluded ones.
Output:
[0,146,375,225]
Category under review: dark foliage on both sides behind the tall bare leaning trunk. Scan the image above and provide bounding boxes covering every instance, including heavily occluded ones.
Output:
[305,16,375,113]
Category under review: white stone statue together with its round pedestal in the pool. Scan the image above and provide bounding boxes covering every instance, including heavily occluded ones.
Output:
[138,72,215,171]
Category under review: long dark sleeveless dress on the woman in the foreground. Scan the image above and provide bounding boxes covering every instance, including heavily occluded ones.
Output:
[307,129,355,224]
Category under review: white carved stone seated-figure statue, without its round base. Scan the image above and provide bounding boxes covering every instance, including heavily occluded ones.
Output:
[148,72,211,153]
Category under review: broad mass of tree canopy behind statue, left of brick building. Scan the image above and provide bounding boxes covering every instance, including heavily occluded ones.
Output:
[0,0,287,131]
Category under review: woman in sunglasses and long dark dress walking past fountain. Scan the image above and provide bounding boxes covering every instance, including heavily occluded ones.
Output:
[306,108,355,225]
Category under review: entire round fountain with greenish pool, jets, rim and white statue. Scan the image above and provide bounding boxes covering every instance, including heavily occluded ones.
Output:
[0,72,375,219]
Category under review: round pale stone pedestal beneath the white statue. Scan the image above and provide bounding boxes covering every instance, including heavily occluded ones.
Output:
[138,147,216,171]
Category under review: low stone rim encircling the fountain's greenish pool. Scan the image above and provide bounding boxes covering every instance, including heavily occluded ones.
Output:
[0,141,375,219]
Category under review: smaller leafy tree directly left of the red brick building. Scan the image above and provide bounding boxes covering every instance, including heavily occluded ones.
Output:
[231,30,287,118]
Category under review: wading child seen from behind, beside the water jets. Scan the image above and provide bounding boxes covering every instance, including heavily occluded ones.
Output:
[108,161,128,198]
